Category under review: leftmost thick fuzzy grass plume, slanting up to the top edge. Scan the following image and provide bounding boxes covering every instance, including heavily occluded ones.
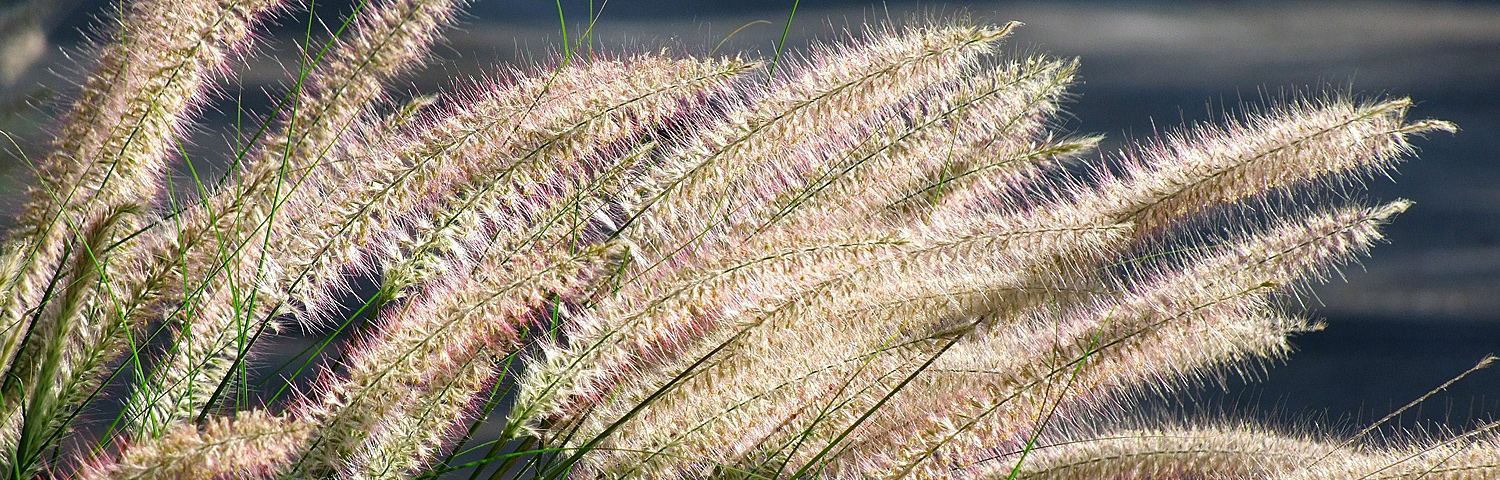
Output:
[0,0,281,473]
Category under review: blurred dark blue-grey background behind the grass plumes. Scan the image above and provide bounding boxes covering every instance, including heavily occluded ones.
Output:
[0,0,1500,438]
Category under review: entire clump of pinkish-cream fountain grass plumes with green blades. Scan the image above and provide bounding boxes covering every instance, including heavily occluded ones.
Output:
[0,0,1482,480]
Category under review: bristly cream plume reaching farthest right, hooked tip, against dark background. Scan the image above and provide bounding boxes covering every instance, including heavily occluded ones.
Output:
[1077,98,1452,234]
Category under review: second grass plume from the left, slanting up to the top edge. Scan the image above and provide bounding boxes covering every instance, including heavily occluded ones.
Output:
[126,0,474,435]
